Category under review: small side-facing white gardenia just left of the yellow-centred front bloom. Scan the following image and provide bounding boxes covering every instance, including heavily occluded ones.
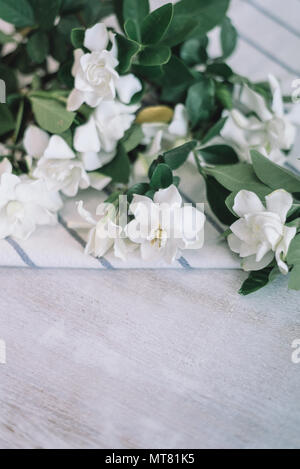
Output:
[78,201,132,261]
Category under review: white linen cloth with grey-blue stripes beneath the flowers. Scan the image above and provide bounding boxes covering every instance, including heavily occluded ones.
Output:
[0,0,300,270]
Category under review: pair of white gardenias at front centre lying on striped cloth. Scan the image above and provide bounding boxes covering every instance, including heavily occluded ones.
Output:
[78,185,205,263]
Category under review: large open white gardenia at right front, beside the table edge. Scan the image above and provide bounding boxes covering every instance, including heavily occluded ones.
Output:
[228,190,297,274]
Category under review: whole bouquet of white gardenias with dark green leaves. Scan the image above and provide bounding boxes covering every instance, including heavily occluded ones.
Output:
[0,0,300,295]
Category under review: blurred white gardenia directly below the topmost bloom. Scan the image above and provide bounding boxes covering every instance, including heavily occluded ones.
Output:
[74,101,139,171]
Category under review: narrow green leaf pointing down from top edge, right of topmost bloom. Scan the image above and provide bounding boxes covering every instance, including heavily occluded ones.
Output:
[123,0,150,42]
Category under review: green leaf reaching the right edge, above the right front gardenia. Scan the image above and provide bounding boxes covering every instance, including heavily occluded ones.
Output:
[251,150,300,193]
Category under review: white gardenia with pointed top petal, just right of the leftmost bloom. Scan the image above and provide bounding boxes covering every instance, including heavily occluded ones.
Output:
[33,135,90,197]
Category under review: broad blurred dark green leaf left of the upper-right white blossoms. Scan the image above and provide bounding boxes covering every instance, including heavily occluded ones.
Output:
[186,78,215,127]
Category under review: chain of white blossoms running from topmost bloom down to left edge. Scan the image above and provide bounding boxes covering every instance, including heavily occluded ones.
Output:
[0,23,142,239]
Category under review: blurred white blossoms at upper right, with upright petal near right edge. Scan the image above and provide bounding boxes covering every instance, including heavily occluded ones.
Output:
[221,75,299,164]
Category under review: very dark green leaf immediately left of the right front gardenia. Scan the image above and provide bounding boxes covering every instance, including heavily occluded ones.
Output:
[205,176,237,226]
